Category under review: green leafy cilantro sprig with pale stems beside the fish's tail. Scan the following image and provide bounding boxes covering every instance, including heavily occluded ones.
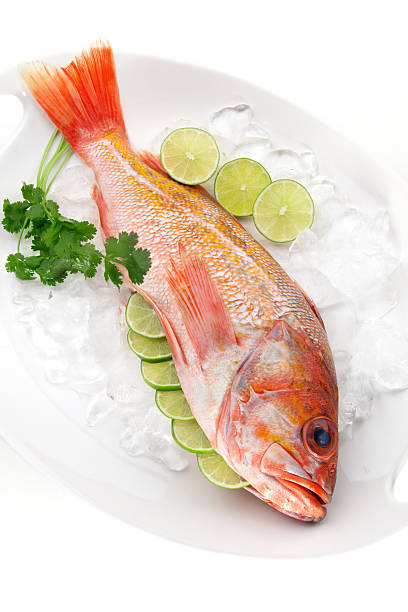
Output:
[2,130,151,287]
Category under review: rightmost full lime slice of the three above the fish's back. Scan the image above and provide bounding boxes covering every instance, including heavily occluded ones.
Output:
[253,179,314,242]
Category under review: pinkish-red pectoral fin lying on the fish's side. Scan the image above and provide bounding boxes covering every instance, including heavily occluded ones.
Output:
[167,244,238,359]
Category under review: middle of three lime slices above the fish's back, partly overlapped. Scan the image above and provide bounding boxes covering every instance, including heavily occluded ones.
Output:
[214,157,271,217]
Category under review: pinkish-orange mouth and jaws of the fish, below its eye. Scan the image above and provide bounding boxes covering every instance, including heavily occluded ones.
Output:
[260,442,334,521]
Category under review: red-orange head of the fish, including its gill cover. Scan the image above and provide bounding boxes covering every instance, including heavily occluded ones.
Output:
[224,322,338,521]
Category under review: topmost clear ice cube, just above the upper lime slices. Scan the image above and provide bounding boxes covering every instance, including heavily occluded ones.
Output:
[209,104,253,145]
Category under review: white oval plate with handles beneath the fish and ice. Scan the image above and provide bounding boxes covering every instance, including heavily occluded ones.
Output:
[0,55,408,557]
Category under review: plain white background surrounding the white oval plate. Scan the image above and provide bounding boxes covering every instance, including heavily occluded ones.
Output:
[0,0,408,612]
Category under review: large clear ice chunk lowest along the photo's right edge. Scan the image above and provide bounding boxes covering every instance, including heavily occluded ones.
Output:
[352,320,408,389]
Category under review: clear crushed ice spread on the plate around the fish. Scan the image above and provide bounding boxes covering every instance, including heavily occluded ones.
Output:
[10,104,408,470]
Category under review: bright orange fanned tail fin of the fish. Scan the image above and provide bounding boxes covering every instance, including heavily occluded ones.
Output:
[20,43,126,150]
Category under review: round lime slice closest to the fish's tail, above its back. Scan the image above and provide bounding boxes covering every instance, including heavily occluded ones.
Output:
[160,127,220,185]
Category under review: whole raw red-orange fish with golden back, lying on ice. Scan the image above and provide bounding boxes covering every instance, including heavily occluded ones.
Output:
[21,43,337,521]
